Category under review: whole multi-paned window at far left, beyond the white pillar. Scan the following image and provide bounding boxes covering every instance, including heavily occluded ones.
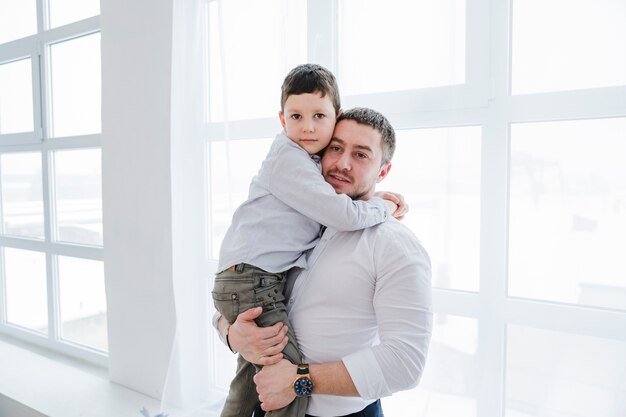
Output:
[0,0,107,364]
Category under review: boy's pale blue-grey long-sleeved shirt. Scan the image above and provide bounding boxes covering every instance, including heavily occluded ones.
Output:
[218,133,389,272]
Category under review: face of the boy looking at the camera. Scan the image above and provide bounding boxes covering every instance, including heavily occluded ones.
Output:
[278,93,337,155]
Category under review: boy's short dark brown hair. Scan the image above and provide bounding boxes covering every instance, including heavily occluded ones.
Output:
[280,64,341,115]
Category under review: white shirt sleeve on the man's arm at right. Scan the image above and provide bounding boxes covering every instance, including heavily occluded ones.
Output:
[342,229,432,400]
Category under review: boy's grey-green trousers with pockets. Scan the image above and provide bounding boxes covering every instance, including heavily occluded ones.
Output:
[212,264,309,417]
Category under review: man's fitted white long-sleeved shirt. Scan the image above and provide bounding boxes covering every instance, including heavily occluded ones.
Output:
[287,219,432,417]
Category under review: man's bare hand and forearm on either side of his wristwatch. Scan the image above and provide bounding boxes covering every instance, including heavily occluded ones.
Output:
[254,359,359,411]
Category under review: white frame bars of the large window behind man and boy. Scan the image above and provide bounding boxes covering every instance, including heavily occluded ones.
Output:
[206,0,626,416]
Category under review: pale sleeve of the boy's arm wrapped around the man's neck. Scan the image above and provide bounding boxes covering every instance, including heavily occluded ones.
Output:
[268,139,390,231]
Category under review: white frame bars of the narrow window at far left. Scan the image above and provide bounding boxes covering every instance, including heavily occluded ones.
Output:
[0,0,108,366]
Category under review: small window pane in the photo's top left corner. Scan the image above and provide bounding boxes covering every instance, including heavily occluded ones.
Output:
[0,0,37,44]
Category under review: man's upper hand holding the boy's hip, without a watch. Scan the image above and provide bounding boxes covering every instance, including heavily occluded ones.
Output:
[225,307,287,366]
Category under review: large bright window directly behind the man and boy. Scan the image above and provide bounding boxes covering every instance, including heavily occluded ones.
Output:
[206,0,626,417]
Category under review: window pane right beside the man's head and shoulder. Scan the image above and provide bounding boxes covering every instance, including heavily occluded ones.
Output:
[378,127,481,291]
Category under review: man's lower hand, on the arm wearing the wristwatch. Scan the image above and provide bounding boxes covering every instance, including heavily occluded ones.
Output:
[254,359,297,411]
